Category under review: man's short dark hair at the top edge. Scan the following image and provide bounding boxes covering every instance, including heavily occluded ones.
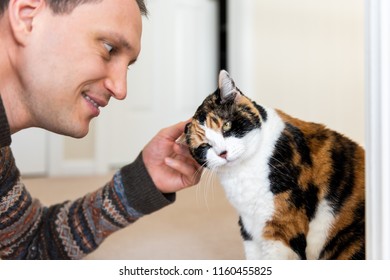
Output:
[0,0,148,17]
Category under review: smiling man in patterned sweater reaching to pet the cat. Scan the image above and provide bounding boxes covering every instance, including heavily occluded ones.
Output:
[0,0,199,259]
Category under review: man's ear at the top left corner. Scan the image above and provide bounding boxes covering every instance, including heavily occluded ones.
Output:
[8,0,46,44]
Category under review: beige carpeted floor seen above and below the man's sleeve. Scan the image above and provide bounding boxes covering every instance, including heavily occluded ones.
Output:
[23,174,244,260]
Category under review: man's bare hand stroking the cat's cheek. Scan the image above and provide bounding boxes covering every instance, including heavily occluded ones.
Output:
[142,122,202,193]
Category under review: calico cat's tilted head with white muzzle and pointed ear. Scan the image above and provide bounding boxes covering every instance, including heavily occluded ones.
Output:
[185,70,267,169]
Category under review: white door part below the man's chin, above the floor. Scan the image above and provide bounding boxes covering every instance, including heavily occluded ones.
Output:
[11,128,48,176]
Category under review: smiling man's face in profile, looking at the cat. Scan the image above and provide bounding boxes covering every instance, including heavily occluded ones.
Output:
[18,0,142,137]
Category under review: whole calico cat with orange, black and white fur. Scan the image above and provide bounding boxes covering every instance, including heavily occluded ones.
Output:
[184,70,365,259]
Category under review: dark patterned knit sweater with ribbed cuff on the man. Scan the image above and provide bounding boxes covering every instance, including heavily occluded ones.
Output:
[0,97,175,259]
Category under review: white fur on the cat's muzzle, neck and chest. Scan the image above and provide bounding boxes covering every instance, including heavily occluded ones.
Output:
[203,106,298,259]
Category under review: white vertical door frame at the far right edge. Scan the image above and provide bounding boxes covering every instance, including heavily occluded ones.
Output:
[365,0,390,260]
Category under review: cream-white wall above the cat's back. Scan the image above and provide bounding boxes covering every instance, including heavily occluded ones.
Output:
[229,0,365,144]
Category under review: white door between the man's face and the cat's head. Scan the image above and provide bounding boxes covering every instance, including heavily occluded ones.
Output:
[96,0,218,168]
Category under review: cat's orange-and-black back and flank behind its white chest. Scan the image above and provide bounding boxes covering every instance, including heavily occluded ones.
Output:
[269,111,365,259]
